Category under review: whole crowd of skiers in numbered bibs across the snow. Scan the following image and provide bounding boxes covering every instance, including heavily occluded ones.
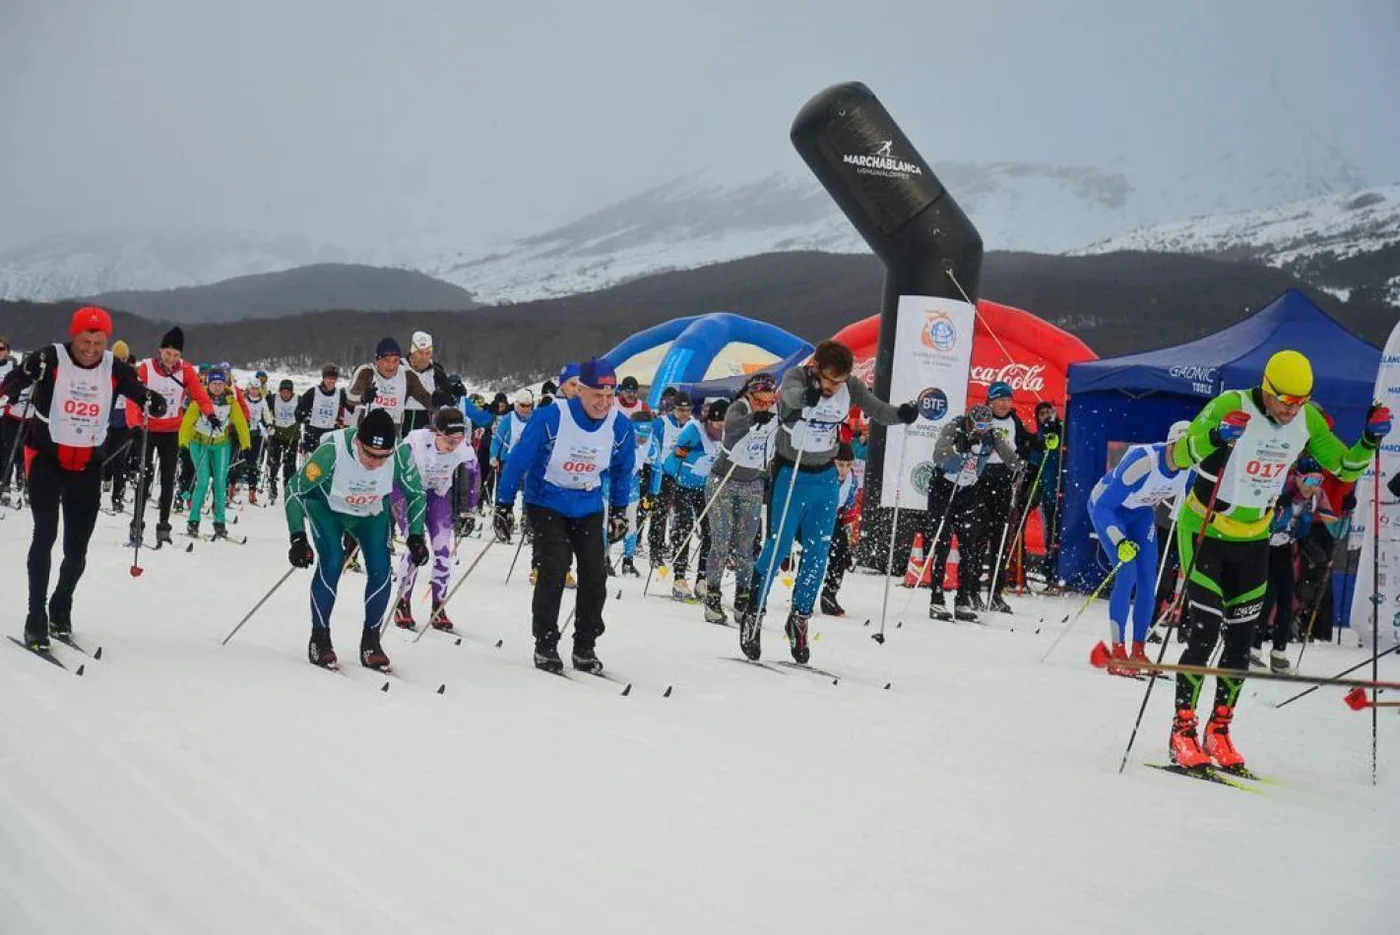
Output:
[0,307,1390,768]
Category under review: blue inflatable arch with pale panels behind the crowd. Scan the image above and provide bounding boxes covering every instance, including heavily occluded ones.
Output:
[606,312,813,406]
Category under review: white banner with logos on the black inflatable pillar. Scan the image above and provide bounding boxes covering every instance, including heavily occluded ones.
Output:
[881,295,977,509]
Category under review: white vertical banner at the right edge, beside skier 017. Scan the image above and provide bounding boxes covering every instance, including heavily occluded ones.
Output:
[1343,325,1400,647]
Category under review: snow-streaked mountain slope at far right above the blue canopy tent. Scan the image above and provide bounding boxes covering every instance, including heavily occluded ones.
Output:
[1074,185,1400,305]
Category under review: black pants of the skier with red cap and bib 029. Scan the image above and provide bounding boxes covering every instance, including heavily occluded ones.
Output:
[28,452,102,620]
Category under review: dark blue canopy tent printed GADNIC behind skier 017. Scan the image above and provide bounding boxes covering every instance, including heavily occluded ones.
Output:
[1058,290,1380,589]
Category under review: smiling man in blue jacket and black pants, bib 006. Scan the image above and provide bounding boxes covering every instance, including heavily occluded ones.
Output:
[496,358,637,673]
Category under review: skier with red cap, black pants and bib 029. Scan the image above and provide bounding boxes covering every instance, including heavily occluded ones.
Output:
[0,305,165,654]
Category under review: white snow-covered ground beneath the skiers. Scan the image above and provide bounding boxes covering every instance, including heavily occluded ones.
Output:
[0,507,1400,935]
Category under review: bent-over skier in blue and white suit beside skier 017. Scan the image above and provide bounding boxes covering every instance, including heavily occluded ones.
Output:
[1089,421,1191,675]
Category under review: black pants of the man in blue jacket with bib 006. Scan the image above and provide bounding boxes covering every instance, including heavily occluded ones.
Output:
[525,504,608,649]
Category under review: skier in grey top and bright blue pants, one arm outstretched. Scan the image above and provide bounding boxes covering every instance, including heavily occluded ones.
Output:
[739,340,918,663]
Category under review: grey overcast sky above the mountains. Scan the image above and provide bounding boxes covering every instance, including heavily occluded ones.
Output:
[0,0,1400,246]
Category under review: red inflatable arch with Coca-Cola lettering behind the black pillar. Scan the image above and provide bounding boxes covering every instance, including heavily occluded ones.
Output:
[833,300,1099,551]
